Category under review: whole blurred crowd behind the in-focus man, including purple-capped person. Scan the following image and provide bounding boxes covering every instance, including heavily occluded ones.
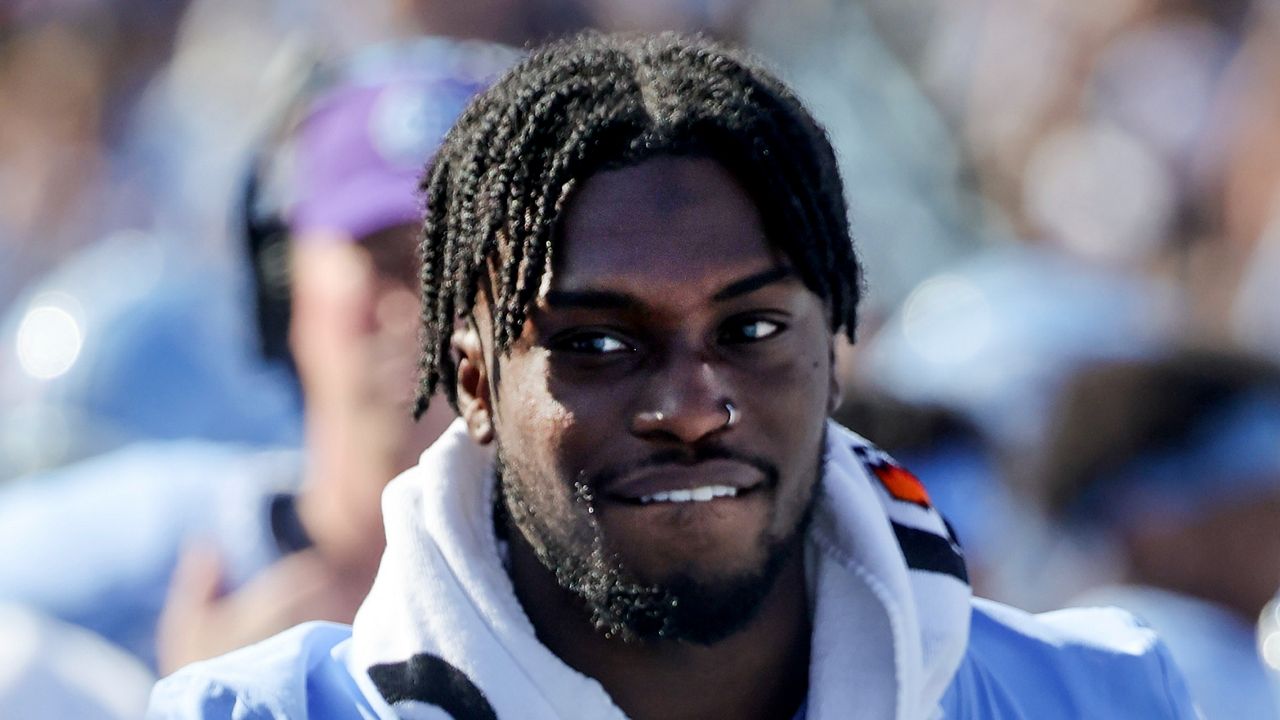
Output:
[0,0,1280,720]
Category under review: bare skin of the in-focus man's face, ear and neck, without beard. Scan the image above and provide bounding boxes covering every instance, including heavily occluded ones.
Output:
[453,158,838,720]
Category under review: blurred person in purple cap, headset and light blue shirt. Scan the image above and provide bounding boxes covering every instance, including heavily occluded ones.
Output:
[0,33,516,674]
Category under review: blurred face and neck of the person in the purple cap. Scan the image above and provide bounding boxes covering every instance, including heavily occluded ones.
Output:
[291,225,452,569]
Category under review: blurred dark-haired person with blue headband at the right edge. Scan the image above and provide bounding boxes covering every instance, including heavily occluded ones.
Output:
[1041,350,1280,720]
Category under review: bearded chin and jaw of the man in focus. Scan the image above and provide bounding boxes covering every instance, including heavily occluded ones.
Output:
[498,447,813,644]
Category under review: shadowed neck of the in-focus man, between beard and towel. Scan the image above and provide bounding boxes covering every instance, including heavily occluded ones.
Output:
[508,528,810,720]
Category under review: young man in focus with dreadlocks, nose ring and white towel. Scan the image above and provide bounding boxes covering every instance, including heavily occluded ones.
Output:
[152,36,1193,719]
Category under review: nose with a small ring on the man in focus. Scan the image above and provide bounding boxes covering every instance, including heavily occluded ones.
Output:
[631,355,736,445]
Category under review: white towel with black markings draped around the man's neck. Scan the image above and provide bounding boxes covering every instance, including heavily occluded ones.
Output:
[348,420,970,720]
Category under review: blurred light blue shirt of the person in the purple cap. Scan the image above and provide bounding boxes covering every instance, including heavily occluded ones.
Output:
[0,441,301,669]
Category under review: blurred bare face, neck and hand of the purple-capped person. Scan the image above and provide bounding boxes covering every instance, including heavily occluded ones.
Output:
[157,225,452,671]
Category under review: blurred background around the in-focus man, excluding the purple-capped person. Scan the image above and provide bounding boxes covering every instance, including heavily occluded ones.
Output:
[0,0,1280,719]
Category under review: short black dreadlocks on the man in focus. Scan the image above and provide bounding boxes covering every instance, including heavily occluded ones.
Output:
[415,33,861,415]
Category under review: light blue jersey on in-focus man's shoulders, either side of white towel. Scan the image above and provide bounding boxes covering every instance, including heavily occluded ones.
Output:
[147,600,1197,720]
